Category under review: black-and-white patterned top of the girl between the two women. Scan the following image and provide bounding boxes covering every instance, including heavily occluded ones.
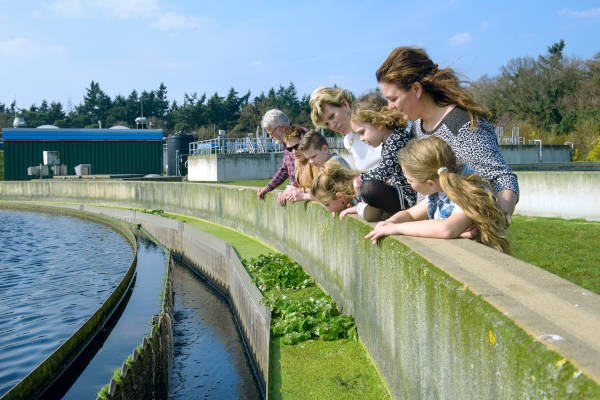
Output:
[359,128,417,206]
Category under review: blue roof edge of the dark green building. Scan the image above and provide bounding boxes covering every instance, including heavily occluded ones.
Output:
[2,128,163,142]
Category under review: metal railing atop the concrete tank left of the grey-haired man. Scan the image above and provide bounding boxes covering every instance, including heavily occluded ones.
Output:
[189,137,283,156]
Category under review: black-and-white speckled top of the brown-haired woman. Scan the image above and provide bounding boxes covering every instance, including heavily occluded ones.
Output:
[411,107,519,196]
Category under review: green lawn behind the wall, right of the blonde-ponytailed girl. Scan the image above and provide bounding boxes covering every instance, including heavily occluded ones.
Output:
[508,215,600,294]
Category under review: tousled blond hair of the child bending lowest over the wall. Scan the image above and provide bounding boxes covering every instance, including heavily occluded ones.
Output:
[310,160,360,203]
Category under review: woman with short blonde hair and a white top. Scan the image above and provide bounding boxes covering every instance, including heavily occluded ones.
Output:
[308,87,381,171]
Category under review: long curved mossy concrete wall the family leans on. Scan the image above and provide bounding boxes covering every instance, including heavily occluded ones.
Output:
[0,181,600,399]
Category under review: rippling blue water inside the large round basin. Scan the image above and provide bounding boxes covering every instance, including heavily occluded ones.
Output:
[0,209,132,396]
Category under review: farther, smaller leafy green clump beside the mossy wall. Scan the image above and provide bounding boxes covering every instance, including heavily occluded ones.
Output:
[242,254,315,292]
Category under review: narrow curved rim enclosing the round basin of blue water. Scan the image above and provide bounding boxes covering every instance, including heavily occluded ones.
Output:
[0,202,137,400]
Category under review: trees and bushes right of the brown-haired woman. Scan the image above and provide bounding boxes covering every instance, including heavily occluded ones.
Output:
[470,40,600,161]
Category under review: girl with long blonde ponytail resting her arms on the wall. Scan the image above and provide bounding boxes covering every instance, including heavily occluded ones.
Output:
[365,136,509,253]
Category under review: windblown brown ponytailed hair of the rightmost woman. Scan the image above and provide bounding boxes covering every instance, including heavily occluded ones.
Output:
[375,47,490,129]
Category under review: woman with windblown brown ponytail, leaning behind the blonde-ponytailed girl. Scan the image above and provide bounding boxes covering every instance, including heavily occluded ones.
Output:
[376,47,519,223]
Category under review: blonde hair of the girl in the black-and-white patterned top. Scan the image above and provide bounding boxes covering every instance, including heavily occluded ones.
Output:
[351,92,406,131]
